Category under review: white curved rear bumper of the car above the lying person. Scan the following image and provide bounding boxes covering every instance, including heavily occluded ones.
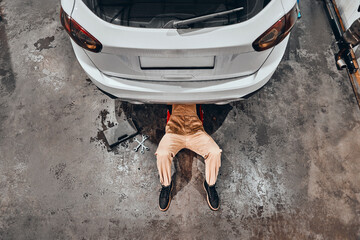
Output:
[71,36,289,104]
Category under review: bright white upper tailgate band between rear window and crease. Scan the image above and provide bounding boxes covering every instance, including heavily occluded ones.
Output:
[71,0,284,51]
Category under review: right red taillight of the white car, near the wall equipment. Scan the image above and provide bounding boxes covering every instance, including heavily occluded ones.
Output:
[253,4,298,52]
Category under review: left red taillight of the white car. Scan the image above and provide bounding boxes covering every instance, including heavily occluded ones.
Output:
[60,8,102,52]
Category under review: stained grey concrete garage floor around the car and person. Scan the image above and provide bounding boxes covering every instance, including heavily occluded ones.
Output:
[0,0,360,239]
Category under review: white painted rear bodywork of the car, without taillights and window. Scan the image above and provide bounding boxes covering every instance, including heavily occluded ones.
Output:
[64,0,296,103]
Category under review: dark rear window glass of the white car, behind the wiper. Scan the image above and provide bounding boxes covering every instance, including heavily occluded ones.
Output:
[83,0,271,28]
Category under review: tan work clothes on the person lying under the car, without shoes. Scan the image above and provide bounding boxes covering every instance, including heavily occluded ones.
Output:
[155,104,222,186]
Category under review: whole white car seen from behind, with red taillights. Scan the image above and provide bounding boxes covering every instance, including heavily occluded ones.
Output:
[60,0,298,104]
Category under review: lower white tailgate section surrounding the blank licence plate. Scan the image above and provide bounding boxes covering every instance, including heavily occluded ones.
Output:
[87,49,271,81]
